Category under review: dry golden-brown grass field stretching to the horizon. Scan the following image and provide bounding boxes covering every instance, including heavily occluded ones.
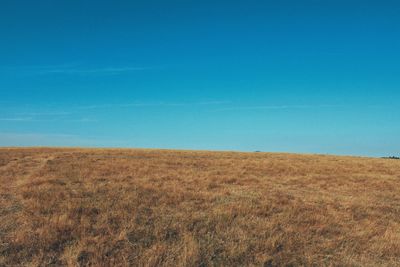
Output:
[0,148,400,266]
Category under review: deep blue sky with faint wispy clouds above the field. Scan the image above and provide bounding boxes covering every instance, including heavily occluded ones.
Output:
[0,0,400,156]
